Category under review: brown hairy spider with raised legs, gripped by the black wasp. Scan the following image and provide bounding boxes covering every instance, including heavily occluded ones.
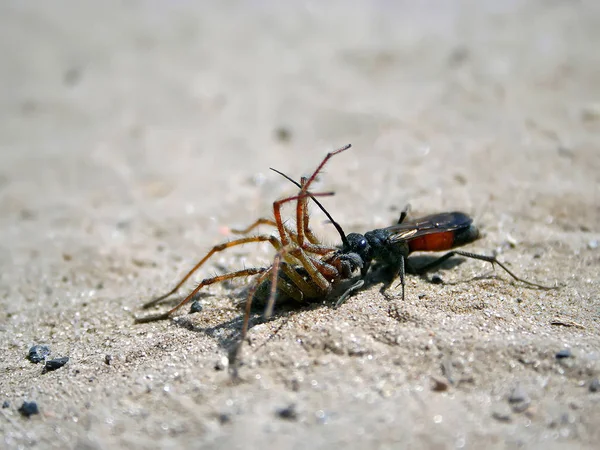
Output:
[135,145,364,359]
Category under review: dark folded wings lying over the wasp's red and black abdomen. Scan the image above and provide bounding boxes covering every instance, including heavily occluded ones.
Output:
[385,211,473,242]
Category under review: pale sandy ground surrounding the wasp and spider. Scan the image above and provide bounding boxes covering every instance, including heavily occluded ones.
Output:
[0,0,600,449]
